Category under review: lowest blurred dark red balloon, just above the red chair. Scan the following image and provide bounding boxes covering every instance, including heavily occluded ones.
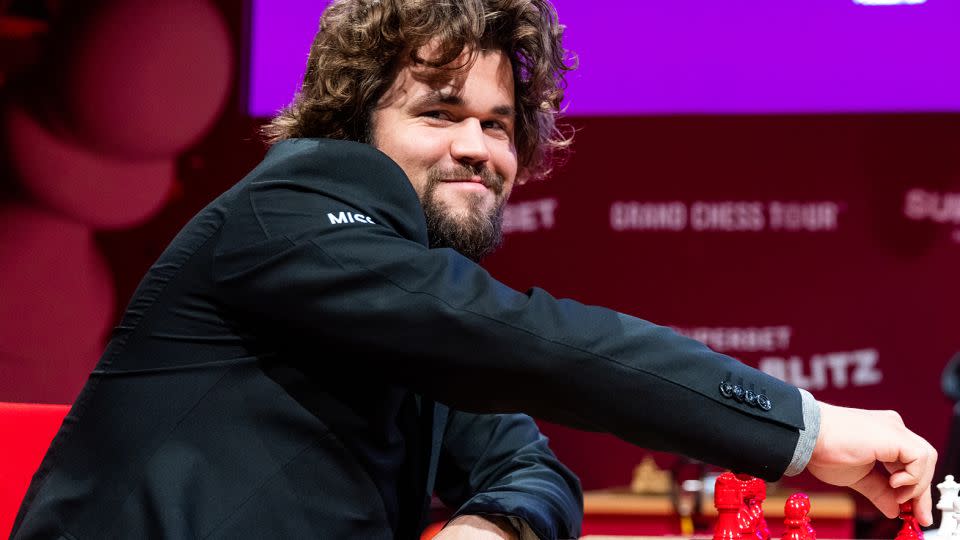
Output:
[0,204,115,367]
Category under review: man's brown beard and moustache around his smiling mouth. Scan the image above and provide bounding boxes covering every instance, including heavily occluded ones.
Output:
[420,163,506,262]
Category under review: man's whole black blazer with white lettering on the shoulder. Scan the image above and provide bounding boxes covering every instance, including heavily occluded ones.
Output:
[13,139,802,539]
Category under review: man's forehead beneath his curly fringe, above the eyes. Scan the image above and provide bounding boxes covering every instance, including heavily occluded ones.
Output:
[380,51,514,110]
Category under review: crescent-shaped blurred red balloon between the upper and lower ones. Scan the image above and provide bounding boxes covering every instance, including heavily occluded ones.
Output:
[3,106,174,229]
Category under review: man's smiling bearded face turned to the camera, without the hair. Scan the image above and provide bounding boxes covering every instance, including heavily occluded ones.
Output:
[370,51,518,260]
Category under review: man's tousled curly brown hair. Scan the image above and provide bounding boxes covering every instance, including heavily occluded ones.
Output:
[263,0,576,178]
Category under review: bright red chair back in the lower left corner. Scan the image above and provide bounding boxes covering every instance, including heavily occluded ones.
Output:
[0,402,70,538]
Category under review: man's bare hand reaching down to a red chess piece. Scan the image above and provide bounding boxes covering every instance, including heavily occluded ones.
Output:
[807,402,937,525]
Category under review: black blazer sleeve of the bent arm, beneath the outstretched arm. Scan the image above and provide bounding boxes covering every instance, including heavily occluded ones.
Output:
[436,410,583,539]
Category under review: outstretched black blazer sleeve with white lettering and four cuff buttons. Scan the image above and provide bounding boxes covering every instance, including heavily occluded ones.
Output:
[212,140,803,480]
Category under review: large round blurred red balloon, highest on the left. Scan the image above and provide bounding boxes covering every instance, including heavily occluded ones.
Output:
[51,0,234,158]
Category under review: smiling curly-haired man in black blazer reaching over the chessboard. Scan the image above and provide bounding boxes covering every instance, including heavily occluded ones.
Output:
[14,0,936,539]
